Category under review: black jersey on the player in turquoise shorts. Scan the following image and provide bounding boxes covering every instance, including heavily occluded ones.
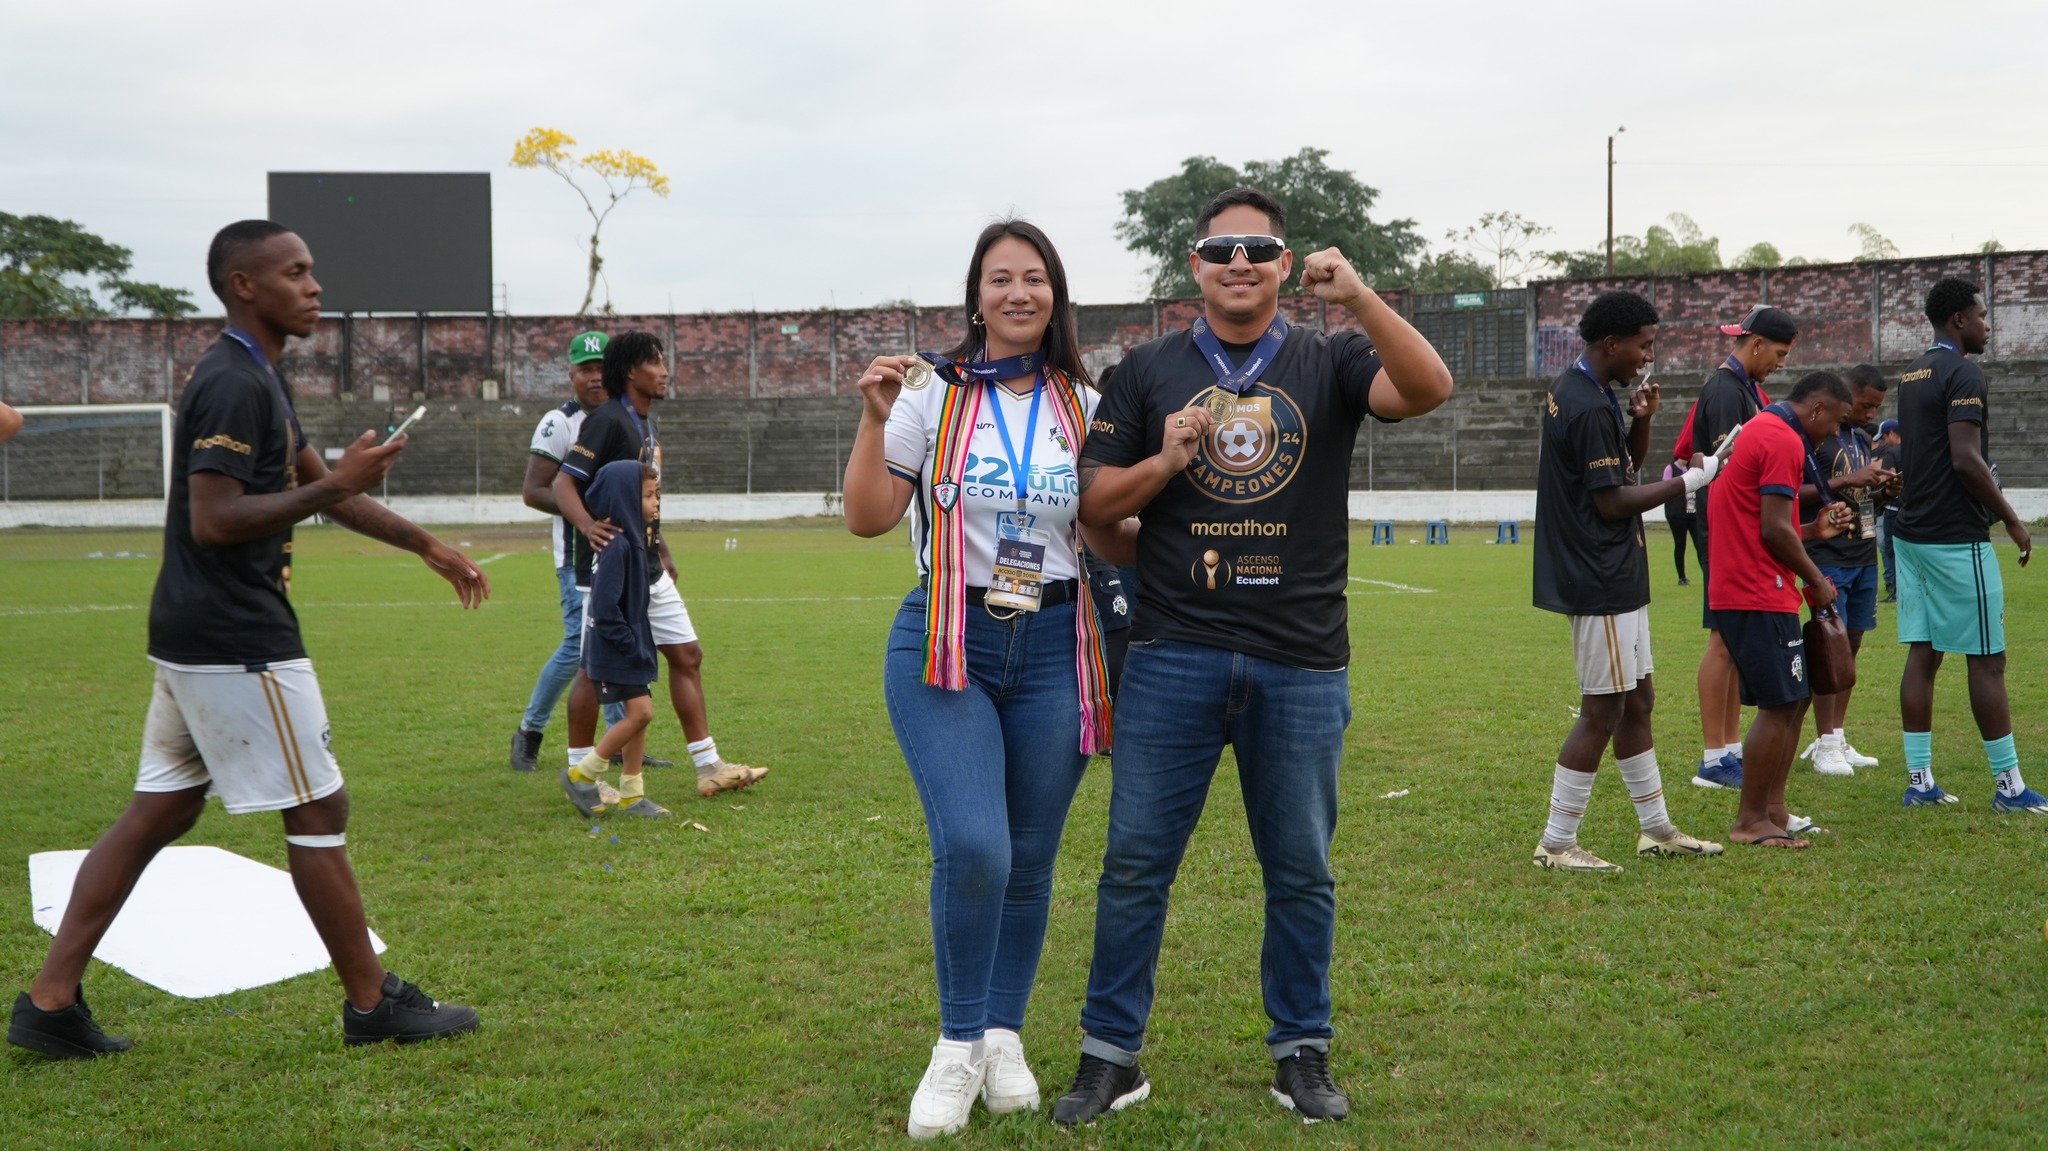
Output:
[1898,344,1991,543]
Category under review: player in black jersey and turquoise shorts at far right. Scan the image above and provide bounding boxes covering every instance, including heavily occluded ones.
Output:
[1892,276,2048,815]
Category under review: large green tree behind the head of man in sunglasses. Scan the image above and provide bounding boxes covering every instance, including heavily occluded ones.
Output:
[1116,147,1425,299]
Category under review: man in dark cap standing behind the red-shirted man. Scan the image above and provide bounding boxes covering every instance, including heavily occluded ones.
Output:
[1690,303,1798,791]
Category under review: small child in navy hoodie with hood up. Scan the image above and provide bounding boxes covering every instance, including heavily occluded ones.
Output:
[561,459,670,819]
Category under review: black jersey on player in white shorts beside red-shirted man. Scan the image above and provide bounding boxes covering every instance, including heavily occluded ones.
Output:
[1534,367,1651,616]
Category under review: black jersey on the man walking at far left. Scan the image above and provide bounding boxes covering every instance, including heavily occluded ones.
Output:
[150,336,305,666]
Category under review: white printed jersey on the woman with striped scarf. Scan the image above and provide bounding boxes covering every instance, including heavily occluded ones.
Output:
[883,379,1102,588]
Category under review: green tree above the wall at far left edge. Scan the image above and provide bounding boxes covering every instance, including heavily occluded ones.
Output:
[0,211,199,319]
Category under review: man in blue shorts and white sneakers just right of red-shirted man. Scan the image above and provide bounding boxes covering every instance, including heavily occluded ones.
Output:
[1800,365,1892,776]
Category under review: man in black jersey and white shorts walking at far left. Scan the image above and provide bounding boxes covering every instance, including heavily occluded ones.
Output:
[8,219,489,1059]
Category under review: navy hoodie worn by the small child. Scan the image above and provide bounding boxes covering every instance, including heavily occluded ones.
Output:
[584,459,657,684]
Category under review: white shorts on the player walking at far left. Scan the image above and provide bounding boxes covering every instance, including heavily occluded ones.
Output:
[135,659,342,815]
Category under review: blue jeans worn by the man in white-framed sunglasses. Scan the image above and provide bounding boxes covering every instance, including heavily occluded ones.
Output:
[1081,641,1352,1063]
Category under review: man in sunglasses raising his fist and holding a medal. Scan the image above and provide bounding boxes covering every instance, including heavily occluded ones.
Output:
[1053,188,1452,1124]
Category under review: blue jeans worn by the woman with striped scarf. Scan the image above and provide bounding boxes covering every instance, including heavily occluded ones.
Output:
[883,588,1087,1040]
